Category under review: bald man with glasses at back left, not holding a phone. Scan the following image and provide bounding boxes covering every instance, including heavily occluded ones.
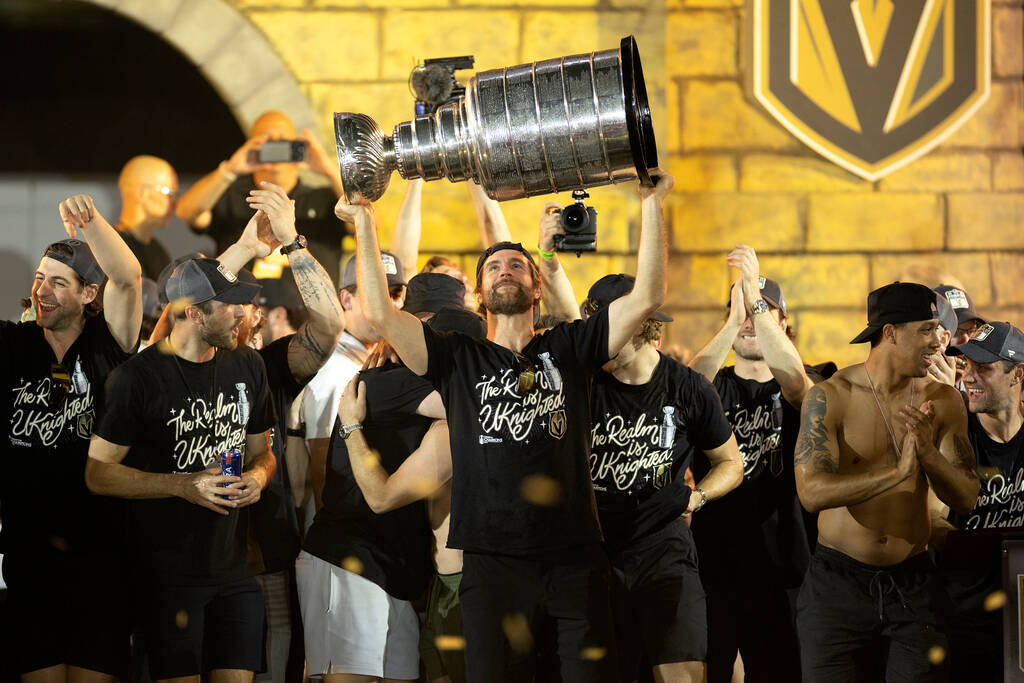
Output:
[116,155,178,281]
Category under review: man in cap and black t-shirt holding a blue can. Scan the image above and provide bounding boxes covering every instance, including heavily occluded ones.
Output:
[85,258,275,681]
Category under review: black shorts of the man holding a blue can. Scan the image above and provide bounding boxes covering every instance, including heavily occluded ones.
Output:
[145,578,263,681]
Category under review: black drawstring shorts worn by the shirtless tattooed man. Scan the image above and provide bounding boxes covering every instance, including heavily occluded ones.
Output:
[797,545,949,683]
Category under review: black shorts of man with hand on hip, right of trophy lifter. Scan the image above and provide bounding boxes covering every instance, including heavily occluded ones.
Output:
[610,521,708,681]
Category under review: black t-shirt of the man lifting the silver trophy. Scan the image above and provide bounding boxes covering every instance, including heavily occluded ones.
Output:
[423,309,608,555]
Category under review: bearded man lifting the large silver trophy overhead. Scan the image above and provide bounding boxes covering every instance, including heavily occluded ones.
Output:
[336,167,673,683]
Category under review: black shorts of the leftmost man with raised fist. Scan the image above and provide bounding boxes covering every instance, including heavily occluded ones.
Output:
[3,549,132,679]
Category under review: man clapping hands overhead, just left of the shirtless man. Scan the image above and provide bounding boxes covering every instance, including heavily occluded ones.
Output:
[689,245,811,683]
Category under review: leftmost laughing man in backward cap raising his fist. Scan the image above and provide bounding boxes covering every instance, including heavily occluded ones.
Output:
[0,195,142,683]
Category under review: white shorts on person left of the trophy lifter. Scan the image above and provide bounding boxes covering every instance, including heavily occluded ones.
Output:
[295,551,420,680]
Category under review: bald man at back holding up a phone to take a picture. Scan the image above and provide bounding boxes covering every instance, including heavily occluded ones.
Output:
[177,112,347,282]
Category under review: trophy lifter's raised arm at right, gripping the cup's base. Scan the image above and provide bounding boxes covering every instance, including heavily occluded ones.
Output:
[608,169,675,356]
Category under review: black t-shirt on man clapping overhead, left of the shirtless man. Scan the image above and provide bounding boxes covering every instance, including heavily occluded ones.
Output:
[691,367,810,586]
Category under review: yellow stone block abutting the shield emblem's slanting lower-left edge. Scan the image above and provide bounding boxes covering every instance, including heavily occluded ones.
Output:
[681,81,800,151]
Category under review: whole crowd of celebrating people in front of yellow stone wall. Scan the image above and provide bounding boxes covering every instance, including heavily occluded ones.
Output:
[0,112,1024,683]
